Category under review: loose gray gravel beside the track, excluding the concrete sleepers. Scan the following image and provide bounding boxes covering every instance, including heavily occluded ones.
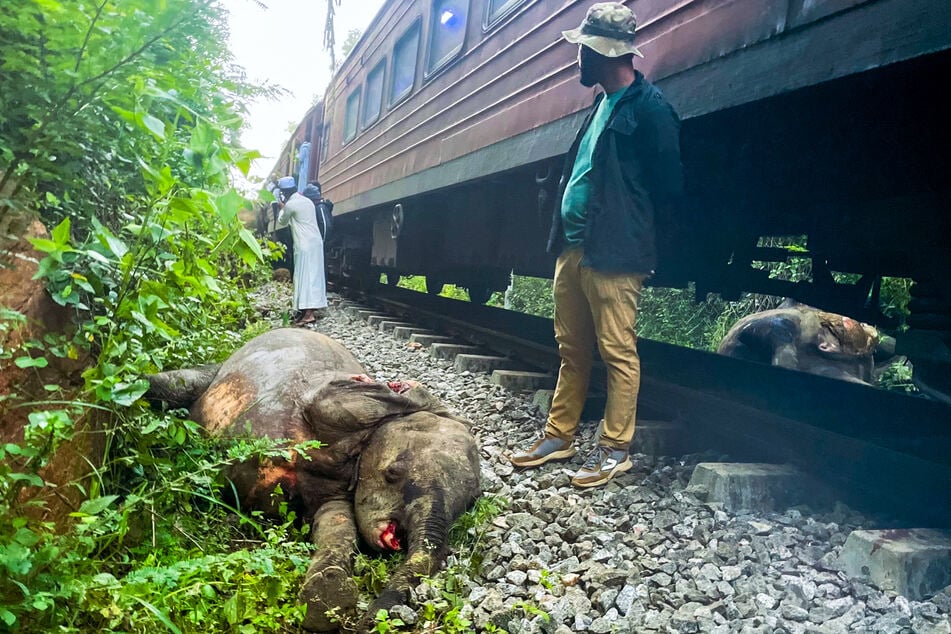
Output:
[247,284,951,634]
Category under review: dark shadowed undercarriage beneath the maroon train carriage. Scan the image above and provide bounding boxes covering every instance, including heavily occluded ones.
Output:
[329,51,951,392]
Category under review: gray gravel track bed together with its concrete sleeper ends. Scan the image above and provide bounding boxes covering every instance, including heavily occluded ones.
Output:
[251,288,951,633]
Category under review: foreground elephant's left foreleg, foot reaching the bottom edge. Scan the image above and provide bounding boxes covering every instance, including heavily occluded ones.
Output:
[300,500,359,632]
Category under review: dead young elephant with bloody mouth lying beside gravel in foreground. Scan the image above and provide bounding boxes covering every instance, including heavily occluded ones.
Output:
[146,329,481,631]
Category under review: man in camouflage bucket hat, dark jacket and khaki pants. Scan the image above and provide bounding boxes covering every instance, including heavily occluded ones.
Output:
[510,2,683,487]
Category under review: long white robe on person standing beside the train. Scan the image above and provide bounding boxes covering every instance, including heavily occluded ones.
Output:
[277,193,327,310]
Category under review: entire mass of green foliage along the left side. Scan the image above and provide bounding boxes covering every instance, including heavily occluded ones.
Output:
[0,0,310,632]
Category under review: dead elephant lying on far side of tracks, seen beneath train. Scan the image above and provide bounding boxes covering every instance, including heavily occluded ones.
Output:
[717,300,895,385]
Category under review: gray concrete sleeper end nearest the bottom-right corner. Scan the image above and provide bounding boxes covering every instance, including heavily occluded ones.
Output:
[839,528,951,599]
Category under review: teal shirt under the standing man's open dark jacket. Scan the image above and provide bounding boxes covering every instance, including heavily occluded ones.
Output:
[561,90,624,247]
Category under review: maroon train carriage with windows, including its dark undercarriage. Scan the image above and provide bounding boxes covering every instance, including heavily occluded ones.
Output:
[266,0,951,380]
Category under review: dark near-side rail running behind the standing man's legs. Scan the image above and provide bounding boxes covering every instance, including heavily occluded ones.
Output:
[340,278,951,526]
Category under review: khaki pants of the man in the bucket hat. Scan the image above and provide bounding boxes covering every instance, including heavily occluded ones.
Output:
[545,248,647,449]
